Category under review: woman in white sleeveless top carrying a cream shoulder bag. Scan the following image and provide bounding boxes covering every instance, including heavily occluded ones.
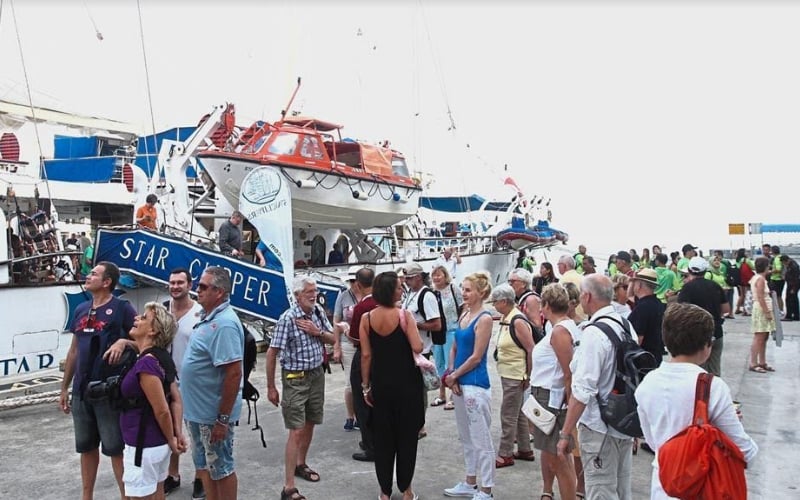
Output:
[531,283,578,500]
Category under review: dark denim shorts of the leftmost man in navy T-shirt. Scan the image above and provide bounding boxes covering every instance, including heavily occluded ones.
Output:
[72,391,125,457]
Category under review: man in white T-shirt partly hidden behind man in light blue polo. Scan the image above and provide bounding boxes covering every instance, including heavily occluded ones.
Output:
[164,268,205,499]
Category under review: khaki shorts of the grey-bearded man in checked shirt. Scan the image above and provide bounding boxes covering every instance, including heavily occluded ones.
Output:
[281,366,325,429]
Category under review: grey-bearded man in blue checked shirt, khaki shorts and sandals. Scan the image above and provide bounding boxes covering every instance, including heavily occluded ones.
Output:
[267,276,339,498]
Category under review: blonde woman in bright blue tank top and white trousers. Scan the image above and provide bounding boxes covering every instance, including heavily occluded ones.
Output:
[444,272,495,500]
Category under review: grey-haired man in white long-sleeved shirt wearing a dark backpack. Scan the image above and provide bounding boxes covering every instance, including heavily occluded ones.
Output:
[558,274,636,500]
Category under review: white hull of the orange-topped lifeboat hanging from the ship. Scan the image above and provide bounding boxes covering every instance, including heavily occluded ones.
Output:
[200,156,421,229]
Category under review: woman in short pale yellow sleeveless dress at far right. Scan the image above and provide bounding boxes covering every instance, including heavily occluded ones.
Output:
[750,257,775,373]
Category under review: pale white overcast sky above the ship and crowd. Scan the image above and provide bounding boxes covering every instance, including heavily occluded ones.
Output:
[0,0,800,260]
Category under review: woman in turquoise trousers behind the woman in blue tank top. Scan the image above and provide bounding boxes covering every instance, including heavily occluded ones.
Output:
[431,265,464,410]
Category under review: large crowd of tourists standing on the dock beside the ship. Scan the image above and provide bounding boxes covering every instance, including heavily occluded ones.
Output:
[60,240,799,500]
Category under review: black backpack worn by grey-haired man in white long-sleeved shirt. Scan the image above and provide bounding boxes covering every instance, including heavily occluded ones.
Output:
[590,316,658,437]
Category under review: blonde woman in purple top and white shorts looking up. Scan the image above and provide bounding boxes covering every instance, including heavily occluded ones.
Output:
[120,302,186,499]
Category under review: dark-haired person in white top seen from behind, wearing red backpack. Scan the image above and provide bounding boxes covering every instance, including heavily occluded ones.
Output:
[636,303,758,499]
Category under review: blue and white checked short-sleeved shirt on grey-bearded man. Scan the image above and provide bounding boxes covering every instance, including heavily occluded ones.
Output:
[269,305,333,371]
